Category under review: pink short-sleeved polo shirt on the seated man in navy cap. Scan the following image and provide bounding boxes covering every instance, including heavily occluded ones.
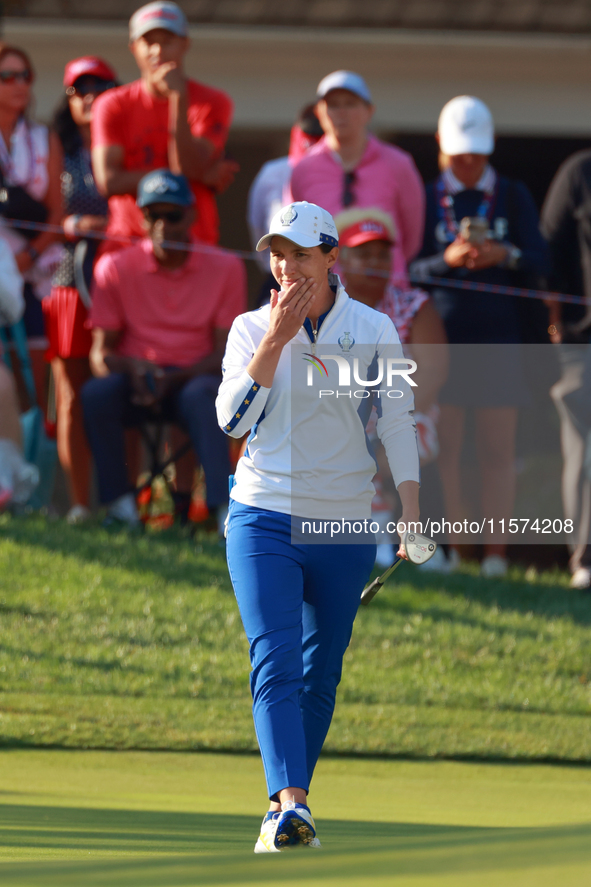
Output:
[90,240,246,367]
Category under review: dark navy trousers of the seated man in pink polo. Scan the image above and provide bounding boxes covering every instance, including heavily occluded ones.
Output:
[81,373,230,509]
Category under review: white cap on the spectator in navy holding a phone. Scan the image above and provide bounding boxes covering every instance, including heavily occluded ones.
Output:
[437,95,495,157]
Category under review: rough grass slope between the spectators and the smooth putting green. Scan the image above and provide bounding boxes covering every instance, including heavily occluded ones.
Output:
[0,516,591,761]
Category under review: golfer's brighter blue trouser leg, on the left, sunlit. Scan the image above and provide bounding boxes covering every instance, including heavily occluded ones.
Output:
[226,502,308,800]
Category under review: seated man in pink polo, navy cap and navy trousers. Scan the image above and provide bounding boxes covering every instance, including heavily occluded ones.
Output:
[82,169,246,525]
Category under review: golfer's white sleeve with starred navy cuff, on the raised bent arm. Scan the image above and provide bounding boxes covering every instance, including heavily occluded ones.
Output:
[215,317,271,438]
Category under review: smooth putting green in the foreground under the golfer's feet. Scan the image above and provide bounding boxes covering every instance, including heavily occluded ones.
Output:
[0,750,591,887]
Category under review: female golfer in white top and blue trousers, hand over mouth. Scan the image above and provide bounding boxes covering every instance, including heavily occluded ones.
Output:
[217,202,419,853]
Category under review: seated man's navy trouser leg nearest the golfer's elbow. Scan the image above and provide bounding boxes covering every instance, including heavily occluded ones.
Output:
[176,376,231,509]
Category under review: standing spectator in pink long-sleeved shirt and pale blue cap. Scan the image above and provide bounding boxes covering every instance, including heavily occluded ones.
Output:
[286,71,425,285]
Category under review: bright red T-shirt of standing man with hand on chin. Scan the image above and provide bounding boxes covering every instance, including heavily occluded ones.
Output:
[92,80,233,244]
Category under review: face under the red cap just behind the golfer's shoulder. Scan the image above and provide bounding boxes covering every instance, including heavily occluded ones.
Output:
[341,240,392,308]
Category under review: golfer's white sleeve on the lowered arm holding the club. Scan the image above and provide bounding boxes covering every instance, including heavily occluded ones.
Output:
[376,318,420,487]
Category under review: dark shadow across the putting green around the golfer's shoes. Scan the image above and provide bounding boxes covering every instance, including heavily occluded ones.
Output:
[0,805,591,887]
